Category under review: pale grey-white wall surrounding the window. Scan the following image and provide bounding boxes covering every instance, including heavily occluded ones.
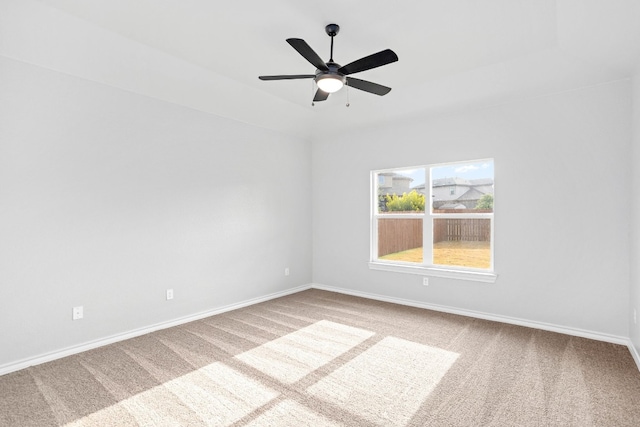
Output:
[312,81,637,338]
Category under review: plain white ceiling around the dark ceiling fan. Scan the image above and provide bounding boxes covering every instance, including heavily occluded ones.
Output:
[0,0,640,138]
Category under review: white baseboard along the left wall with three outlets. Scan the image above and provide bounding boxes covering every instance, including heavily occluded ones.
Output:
[0,285,311,375]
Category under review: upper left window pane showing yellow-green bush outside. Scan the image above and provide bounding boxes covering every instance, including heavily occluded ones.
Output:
[376,168,426,214]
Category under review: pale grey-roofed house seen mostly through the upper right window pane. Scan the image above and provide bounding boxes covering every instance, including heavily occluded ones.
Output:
[413,177,493,209]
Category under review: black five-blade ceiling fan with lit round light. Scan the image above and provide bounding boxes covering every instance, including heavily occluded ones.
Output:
[258,24,398,105]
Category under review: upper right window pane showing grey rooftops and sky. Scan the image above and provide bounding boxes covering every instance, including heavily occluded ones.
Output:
[431,160,493,213]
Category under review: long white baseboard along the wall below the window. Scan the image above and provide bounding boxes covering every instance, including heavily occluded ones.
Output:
[311,283,640,348]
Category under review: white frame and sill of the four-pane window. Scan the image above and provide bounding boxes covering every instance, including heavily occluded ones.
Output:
[369,159,498,283]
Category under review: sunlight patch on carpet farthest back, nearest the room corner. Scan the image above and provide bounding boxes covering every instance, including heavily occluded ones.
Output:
[235,320,374,384]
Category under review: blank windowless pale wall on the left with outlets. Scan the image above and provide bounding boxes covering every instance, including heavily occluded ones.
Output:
[0,57,311,367]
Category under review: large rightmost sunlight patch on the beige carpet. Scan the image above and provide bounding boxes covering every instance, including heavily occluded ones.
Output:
[307,337,459,426]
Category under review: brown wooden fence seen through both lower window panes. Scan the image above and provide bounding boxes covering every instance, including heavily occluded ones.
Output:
[378,218,491,257]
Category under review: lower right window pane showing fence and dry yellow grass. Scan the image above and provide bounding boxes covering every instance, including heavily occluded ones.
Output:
[433,218,491,269]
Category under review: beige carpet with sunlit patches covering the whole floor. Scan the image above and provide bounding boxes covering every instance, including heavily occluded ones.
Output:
[0,290,640,427]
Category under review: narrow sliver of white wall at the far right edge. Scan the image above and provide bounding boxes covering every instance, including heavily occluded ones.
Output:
[629,73,640,362]
